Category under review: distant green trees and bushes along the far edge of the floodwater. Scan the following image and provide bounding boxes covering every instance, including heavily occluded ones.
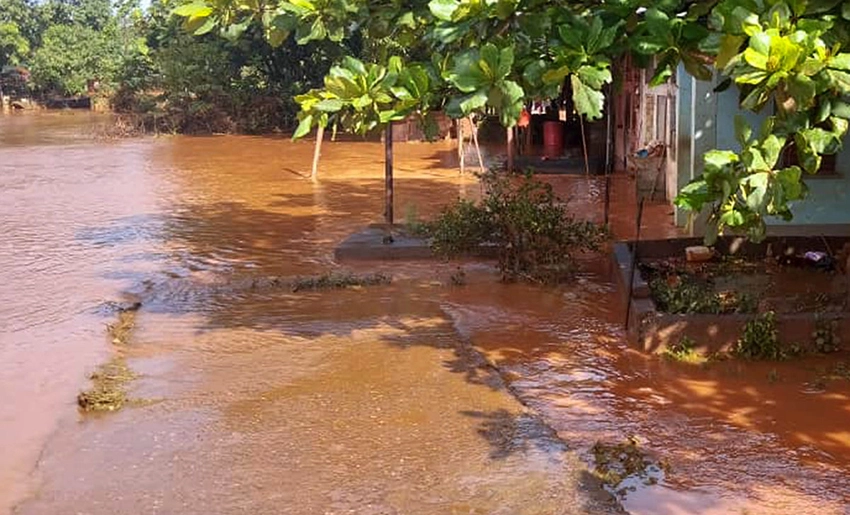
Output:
[0,0,348,133]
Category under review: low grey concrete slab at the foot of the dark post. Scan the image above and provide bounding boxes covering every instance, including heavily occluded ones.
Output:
[334,224,435,261]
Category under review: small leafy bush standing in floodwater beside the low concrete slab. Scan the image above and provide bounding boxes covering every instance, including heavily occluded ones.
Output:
[428,172,606,282]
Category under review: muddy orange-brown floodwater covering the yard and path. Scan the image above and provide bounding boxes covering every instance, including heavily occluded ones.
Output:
[0,114,850,515]
